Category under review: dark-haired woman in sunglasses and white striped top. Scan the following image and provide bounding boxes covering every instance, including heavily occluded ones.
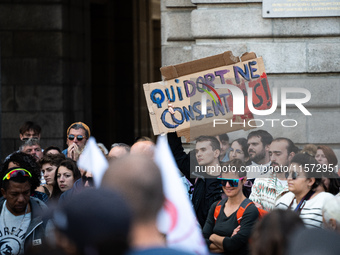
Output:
[276,153,334,228]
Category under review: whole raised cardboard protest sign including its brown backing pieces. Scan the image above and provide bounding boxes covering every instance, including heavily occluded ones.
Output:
[144,52,272,141]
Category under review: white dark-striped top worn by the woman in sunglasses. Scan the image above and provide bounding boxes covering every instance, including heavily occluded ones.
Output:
[275,192,334,228]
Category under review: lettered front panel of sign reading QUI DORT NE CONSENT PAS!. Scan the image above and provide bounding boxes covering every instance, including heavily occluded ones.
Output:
[144,58,272,134]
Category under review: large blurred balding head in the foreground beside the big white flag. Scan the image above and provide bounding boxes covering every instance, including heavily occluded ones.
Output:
[102,155,164,222]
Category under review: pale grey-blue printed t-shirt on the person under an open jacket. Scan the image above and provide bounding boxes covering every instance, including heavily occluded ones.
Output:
[0,201,31,254]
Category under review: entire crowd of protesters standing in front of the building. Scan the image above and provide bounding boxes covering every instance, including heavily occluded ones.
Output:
[0,120,340,255]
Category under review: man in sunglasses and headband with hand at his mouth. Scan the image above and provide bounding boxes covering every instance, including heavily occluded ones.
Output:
[62,122,91,161]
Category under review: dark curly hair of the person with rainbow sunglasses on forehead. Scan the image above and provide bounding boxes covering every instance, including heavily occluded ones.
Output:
[0,152,41,193]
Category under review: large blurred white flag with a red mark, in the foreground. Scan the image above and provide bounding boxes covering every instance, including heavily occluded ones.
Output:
[154,136,209,254]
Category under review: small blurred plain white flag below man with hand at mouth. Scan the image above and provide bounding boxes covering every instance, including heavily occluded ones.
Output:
[77,136,109,188]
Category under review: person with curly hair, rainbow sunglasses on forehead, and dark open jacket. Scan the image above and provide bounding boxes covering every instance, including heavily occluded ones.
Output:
[0,164,47,254]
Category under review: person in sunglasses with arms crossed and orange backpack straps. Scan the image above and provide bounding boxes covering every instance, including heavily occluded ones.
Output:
[203,159,259,254]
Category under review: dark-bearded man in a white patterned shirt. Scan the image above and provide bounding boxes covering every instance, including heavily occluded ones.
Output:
[249,137,298,211]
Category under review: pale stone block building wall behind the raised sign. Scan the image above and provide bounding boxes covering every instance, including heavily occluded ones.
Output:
[161,0,340,158]
